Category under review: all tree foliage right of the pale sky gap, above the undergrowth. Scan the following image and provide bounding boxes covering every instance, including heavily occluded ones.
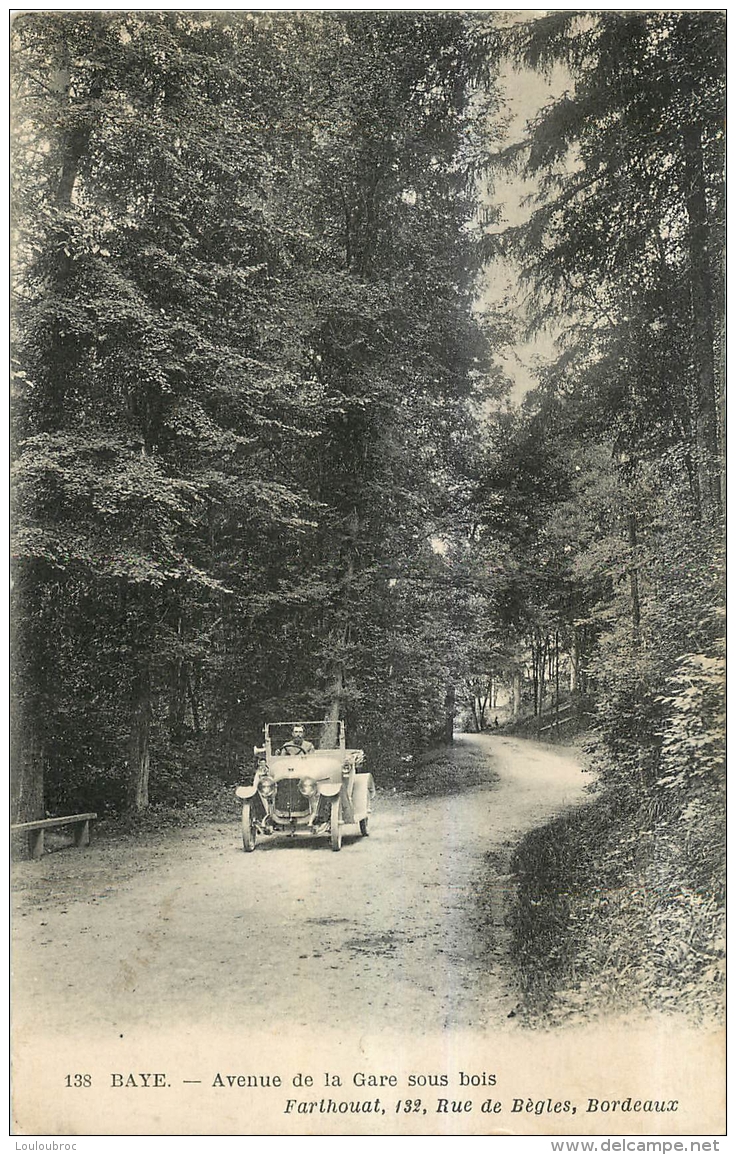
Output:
[477,13,724,822]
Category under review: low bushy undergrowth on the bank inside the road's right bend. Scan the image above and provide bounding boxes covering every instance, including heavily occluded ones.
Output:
[512,791,724,1027]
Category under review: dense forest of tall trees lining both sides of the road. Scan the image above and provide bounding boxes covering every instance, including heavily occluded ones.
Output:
[12,10,724,852]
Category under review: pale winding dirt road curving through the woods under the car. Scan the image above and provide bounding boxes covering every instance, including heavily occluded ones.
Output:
[14,736,588,1037]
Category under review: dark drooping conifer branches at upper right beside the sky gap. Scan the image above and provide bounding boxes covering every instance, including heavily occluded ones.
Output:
[494,12,726,520]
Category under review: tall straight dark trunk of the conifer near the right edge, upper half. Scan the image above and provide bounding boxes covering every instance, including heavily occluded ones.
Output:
[682,125,721,517]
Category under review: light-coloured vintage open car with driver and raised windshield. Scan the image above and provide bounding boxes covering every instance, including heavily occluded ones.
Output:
[236,721,376,851]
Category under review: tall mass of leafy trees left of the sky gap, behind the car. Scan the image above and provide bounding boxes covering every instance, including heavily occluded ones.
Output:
[14,12,506,812]
